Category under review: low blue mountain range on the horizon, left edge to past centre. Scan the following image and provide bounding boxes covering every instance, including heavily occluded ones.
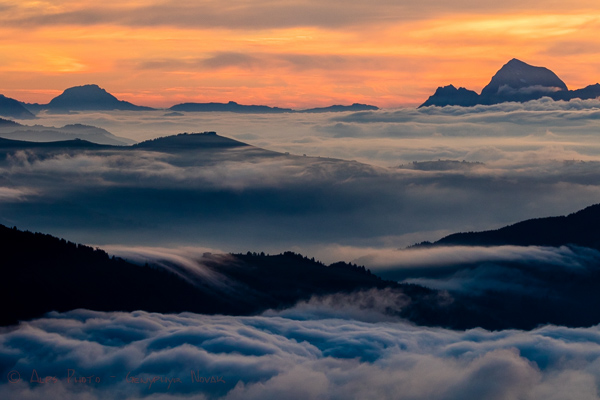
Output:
[0,85,378,115]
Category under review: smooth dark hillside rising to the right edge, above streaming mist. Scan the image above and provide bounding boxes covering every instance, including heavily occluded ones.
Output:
[420,204,600,250]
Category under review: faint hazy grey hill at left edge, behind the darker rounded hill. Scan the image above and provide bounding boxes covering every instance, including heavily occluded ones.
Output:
[0,120,135,146]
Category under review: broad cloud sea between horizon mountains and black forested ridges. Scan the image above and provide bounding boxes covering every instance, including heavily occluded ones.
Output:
[0,99,600,253]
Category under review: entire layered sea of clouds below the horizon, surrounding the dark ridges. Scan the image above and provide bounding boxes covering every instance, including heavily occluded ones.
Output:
[0,99,600,400]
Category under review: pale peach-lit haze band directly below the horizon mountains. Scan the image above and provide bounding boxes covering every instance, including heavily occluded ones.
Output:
[27,99,600,168]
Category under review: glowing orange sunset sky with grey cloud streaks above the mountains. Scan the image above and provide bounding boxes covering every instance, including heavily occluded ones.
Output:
[0,0,600,108]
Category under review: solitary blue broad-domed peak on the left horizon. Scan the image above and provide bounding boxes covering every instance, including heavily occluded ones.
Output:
[40,85,152,112]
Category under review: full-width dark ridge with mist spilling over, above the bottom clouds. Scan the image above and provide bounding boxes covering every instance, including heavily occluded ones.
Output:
[5,208,600,329]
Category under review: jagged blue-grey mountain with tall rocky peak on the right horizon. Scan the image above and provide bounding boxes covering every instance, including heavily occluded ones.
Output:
[419,58,600,108]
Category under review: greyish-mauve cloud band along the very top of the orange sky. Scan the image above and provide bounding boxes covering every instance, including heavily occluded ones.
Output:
[3,0,585,30]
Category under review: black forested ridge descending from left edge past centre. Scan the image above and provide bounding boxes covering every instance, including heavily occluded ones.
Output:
[0,225,448,325]
